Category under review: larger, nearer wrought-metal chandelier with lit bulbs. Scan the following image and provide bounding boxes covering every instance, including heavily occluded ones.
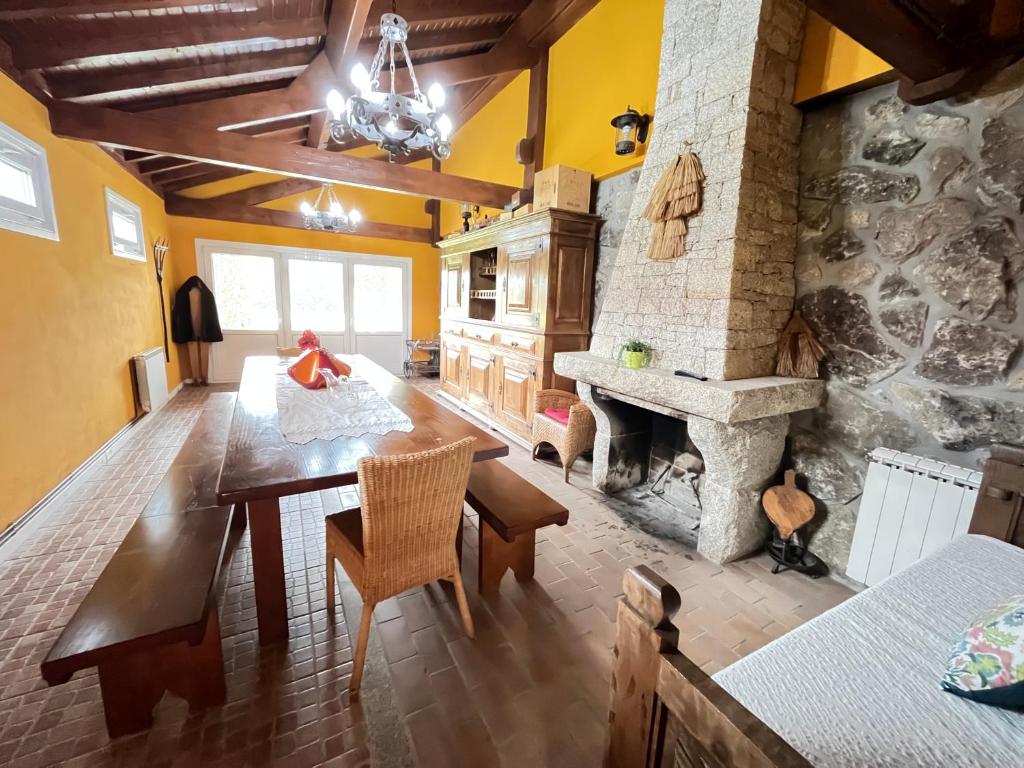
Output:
[327,13,453,160]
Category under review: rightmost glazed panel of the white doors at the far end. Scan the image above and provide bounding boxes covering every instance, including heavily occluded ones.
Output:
[352,261,410,374]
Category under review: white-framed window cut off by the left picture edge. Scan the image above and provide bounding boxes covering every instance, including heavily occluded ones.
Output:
[0,123,60,240]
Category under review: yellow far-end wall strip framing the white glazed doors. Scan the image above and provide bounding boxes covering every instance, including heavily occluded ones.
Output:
[169,215,440,342]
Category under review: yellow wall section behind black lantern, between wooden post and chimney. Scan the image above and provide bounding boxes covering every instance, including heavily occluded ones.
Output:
[544,0,665,179]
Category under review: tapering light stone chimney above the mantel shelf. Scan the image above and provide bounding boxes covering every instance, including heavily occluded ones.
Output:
[591,0,804,379]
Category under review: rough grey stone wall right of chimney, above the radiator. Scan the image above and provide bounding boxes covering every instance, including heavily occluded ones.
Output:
[792,79,1024,570]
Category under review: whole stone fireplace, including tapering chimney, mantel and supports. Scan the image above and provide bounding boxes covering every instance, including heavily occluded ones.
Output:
[555,0,823,562]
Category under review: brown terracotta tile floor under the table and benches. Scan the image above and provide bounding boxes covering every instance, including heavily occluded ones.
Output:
[0,382,850,768]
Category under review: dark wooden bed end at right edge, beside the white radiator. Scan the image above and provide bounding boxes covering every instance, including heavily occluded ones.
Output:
[970,443,1024,549]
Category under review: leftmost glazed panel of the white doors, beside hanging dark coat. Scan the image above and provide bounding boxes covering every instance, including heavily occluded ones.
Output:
[208,249,282,381]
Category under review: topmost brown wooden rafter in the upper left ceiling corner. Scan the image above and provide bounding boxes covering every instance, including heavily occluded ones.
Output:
[14,13,326,70]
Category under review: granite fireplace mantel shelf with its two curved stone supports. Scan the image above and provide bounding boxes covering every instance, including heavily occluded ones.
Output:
[555,352,824,562]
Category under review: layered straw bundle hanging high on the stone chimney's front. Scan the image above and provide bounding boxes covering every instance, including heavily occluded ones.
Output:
[643,141,705,261]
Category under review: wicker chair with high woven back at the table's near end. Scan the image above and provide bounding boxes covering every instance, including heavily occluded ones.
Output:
[327,437,474,693]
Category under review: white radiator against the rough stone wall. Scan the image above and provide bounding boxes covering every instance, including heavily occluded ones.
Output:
[846,449,981,586]
